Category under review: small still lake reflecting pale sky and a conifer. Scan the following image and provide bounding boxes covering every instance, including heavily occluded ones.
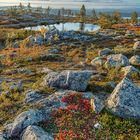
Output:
[25,22,100,32]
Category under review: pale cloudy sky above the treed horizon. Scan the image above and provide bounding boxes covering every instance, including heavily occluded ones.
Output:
[0,0,140,8]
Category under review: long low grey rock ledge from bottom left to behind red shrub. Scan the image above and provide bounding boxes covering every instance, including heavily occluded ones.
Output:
[5,90,98,138]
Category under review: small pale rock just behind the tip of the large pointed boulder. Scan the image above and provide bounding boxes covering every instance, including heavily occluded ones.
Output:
[121,66,140,78]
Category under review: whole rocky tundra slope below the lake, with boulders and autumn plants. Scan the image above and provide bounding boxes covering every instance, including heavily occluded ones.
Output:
[0,29,140,140]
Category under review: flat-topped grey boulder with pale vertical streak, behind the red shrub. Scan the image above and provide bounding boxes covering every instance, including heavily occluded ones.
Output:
[44,71,92,91]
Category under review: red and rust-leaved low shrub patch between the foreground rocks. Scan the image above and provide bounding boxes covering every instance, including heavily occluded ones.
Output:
[41,93,98,140]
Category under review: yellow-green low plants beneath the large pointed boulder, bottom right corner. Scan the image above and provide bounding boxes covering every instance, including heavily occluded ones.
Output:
[98,110,140,140]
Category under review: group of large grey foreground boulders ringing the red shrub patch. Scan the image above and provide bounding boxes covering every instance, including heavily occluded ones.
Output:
[0,70,140,140]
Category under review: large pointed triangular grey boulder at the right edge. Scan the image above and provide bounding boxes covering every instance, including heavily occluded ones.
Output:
[107,78,140,119]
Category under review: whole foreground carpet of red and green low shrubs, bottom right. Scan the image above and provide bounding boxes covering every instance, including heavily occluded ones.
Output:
[41,93,140,140]
